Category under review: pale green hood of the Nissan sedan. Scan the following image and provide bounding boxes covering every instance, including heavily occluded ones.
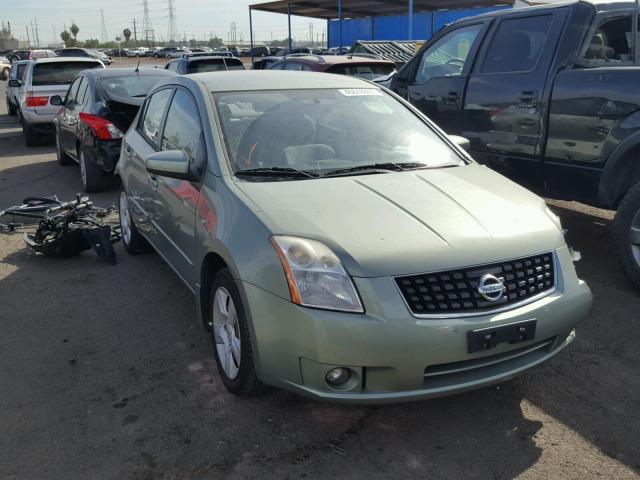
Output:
[238,164,564,277]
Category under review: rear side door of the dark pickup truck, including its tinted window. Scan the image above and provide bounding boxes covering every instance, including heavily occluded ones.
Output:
[462,8,567,188]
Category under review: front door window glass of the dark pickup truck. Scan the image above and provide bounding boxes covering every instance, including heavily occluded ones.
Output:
[415,25,482,84]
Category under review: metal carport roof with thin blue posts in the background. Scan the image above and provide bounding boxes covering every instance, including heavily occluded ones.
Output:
[249,0,515,51]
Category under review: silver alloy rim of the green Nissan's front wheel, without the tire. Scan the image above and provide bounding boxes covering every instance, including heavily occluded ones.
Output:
[213,287,241,380]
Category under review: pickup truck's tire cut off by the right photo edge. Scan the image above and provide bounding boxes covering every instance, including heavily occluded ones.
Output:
[613,184,640,290]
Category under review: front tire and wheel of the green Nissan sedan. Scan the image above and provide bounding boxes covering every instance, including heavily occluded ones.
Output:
[209,268,264,397]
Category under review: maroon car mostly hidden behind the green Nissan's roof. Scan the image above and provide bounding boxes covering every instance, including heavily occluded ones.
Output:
[269,54,395,80]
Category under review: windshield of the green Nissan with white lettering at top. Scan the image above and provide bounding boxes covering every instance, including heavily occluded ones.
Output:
[214,88,464,178]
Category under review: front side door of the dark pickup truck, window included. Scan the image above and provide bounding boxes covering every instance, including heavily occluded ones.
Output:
[398,20,490,134]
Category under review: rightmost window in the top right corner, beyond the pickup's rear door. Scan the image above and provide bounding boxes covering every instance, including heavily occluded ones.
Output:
[581,15,633,66]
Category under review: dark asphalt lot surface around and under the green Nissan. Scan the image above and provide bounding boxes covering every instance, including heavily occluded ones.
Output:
[0,77,640,480]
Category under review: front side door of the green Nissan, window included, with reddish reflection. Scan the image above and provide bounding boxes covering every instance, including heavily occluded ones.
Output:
[155,88,206,285]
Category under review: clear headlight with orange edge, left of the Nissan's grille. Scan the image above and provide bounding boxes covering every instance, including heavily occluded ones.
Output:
[271,235,364,313]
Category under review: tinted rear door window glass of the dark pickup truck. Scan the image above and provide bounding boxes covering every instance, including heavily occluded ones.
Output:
[481,15,553,73]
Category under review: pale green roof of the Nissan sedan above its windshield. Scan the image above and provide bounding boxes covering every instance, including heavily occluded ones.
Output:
[188,70,379,93]
